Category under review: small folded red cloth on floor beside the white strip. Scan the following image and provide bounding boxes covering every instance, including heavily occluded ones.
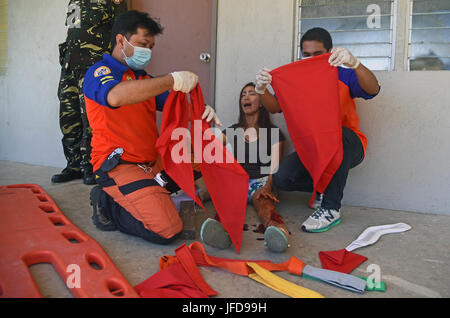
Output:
[319,249,367,274]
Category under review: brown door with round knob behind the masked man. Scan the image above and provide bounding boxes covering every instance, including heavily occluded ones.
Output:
[132,0,217,106]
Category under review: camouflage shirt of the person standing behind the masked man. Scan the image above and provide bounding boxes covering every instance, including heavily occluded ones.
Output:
[59,0,127,69]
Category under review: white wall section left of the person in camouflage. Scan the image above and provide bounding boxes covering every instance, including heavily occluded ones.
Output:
[0,0,67,167]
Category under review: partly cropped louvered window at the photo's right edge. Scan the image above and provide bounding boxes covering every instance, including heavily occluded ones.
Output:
[408,0,450,71]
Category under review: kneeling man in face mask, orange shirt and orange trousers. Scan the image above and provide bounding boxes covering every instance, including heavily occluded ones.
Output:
[84,11,219,244]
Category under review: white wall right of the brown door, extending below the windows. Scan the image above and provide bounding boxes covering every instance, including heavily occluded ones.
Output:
[216,0,450,214]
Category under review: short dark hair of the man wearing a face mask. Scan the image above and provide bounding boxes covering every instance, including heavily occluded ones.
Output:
[111,10,164,50]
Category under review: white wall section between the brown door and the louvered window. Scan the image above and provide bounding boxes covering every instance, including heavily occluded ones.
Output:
[215,0,294,151]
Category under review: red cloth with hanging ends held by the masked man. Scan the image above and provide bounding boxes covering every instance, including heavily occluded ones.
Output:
[157,86,249,253]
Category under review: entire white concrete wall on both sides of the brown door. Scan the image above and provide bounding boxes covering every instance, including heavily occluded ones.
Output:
[0,0,450,214]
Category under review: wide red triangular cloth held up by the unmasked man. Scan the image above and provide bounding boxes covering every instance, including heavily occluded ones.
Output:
[271,54,343,204]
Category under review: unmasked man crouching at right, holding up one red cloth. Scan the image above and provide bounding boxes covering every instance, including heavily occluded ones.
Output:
[256,28,380,233]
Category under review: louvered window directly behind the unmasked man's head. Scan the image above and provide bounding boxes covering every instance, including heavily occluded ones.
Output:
[296,0,398,70]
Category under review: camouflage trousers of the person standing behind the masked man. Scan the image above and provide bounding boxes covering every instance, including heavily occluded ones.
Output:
[58,68,92,170]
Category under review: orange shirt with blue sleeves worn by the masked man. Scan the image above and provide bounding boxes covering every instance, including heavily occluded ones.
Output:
[84,54,168,171]
